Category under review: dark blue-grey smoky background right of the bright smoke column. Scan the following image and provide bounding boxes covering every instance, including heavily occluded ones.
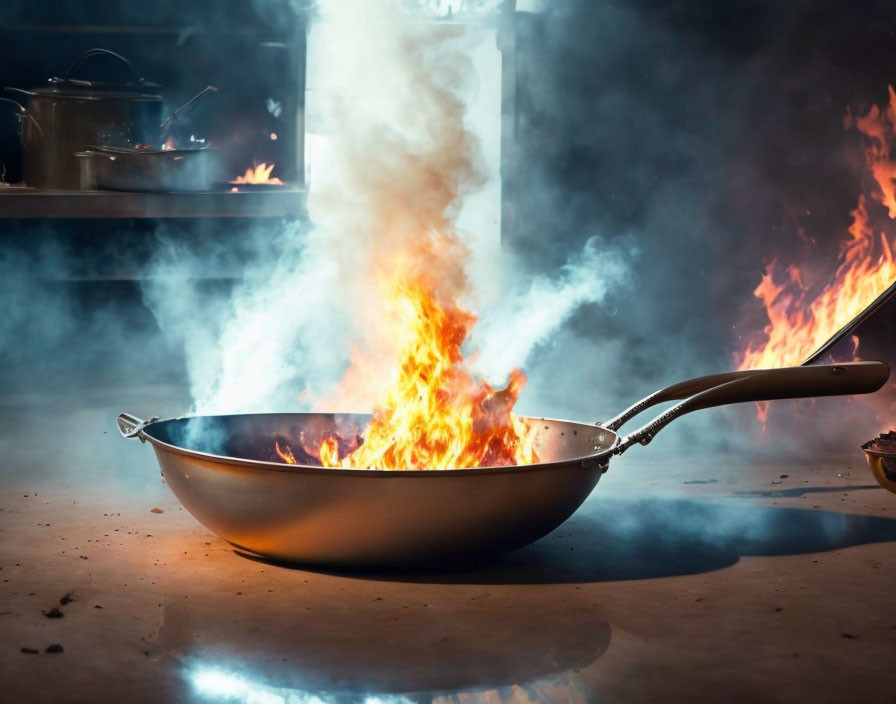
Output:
[505,0,896,412]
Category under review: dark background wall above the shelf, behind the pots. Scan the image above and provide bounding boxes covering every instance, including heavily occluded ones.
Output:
[0,0,304,183]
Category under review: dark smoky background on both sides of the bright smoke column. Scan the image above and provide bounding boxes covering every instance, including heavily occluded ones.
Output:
[0,0,896,440]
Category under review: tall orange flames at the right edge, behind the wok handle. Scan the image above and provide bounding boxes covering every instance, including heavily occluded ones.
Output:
[739,87,896,374]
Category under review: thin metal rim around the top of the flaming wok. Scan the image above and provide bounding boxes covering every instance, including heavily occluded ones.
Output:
[140,413,620,478]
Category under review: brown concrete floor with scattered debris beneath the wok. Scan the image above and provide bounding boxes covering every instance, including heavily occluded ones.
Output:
[0,383,896,703]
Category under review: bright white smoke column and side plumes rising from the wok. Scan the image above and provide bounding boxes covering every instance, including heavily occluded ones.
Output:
[146,0,626,414]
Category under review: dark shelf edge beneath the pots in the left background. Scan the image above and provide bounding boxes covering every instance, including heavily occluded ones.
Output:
[0,186,305,219]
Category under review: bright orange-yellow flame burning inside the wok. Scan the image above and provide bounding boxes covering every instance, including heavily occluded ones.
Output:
[277,245,538,469]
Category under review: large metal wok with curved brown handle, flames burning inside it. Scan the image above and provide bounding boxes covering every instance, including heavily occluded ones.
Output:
[118,362,889,566]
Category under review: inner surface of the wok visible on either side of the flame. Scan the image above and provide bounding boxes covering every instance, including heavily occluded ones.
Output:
[144,413,616,466]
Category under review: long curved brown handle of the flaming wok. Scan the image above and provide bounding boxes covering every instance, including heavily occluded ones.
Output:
[614,362,890,454]
